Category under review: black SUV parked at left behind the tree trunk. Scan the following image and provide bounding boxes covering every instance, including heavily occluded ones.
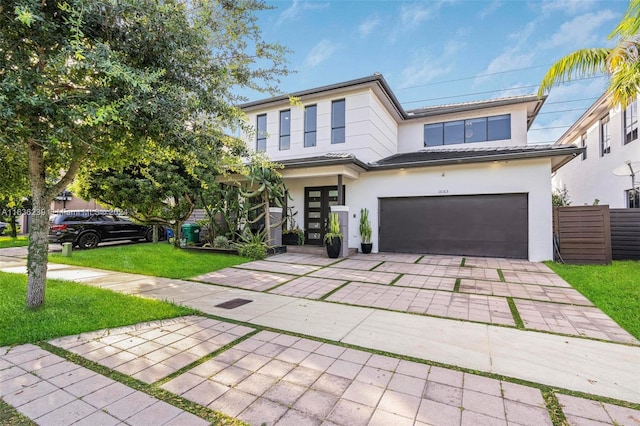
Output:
[49,211,165,249]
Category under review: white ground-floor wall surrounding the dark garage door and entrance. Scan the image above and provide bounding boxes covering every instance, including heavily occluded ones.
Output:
[286,159,553,261]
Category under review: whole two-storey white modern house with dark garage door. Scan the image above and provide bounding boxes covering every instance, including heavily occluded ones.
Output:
[241,74,582,261]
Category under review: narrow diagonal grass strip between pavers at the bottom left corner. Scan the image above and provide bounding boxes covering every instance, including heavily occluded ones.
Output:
[38,342,246,426]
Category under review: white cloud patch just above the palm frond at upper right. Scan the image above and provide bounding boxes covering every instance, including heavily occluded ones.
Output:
[541,10,617,49]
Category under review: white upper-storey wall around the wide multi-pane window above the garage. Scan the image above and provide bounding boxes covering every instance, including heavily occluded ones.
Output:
[398,104,527,153]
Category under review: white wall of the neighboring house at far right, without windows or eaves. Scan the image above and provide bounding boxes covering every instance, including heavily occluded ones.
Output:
[552,102,640,208]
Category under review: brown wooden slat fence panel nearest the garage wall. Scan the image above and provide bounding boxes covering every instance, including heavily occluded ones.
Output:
[553,205,611,264]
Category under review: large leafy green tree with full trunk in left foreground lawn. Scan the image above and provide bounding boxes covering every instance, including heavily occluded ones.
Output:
[0,0,287,308]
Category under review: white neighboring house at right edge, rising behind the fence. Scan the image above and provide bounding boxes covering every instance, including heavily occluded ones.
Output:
[553,94,640,208]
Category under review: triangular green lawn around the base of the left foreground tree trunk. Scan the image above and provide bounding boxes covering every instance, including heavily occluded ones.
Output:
[0,272,195,346]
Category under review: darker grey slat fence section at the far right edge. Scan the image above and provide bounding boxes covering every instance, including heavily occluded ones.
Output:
[609,209,640,260]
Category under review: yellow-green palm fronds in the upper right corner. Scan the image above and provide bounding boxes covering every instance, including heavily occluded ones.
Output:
[538,0,640,106]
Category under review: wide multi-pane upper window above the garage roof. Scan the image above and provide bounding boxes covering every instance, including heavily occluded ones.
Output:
[424,114,511,146]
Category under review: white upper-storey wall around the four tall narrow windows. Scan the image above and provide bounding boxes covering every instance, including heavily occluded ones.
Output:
[244,89,398,162]
